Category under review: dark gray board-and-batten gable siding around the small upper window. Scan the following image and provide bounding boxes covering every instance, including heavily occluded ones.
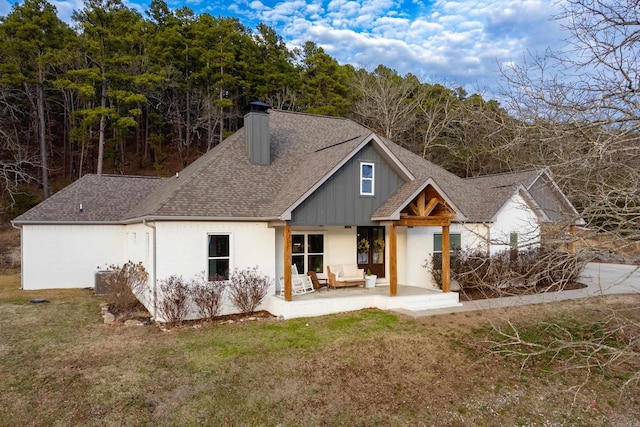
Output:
[289,144,403,226]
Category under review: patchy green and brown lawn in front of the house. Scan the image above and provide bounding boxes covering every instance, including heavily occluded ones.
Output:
[0,272,640,426]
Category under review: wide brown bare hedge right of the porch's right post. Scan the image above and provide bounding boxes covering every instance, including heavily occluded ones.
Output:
[431,248,586,296]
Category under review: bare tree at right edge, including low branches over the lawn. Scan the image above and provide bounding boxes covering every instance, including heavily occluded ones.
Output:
[493,0,640,392]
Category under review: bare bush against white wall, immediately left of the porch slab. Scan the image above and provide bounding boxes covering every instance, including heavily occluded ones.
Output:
[229,267,271,314]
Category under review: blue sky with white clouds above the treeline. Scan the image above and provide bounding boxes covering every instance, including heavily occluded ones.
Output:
[0,0,565,95]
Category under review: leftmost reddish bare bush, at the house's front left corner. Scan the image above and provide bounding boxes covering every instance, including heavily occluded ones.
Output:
[105,261,149,315]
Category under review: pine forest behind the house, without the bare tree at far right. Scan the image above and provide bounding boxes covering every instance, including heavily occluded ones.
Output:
[0,0,507,217]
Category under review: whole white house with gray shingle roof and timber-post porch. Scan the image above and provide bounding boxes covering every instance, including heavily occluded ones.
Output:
[13,109,577,317]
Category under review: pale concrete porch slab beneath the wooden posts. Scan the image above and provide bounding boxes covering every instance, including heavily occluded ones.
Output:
[264,284,461,319]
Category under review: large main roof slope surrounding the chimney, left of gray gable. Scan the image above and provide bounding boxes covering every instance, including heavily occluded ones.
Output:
[128,110,371,219]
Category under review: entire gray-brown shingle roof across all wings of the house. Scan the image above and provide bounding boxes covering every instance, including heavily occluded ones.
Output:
[15,110,572,223]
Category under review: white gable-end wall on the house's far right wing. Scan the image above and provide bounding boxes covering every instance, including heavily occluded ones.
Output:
[490,194,540,255]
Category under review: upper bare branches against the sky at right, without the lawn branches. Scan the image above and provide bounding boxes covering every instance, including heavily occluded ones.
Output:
[503,0,640,244]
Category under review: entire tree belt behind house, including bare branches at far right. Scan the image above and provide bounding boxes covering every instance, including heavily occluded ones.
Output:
[0,0,640,246]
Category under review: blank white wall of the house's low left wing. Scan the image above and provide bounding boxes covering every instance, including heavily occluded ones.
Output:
[22,225,126,289]
